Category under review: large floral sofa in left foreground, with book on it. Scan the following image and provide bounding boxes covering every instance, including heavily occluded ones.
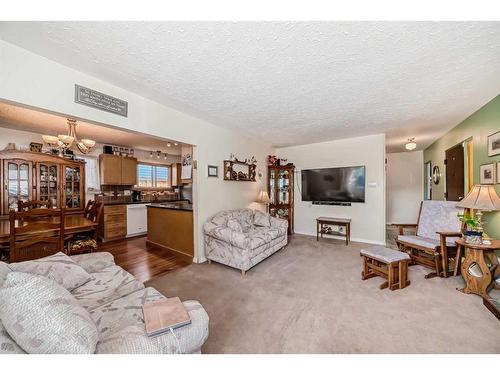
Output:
[0,252,209,354]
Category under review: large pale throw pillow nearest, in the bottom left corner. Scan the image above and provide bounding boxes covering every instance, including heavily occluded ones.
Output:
[0,272,98,354]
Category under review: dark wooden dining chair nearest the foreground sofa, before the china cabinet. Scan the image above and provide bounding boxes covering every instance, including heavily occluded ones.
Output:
[9,208,64,262]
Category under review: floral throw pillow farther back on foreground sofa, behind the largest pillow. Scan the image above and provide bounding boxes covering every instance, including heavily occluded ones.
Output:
[9,252,92,291]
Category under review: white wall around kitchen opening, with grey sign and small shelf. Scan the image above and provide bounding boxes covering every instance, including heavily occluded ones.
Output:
[0,41,272,261]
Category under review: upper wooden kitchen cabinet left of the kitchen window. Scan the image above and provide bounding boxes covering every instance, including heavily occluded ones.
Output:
[99,154,137,186]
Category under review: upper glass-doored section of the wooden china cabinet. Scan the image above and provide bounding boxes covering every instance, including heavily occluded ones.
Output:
[0,151,85,216]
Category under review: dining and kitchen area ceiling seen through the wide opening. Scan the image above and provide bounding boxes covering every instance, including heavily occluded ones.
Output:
[0,102,181,155]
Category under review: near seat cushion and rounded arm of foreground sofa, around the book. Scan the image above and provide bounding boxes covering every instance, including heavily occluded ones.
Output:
[91,288,208,354]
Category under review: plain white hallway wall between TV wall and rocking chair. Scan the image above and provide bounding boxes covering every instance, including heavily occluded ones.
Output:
[386,151,424,224]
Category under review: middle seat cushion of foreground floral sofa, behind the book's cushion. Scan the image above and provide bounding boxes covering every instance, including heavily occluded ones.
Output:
[71,266,144,311]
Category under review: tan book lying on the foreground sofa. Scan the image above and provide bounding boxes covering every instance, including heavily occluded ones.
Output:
[142,297,191,337]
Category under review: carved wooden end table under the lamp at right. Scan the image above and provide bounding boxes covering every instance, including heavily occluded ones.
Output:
[455,238,500,298]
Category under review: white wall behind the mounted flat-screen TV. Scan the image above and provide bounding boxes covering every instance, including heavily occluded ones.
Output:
[276,134,385,244]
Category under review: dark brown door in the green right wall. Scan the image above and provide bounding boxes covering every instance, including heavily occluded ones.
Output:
[444,143,465,201]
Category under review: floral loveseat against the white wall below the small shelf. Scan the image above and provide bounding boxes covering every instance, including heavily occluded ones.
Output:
[203,209,288,275]
